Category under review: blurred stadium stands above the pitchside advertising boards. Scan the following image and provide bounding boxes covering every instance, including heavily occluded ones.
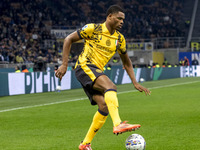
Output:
[0,0,200,70]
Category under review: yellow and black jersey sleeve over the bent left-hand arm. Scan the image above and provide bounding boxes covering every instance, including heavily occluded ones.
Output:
[77,24,94,39]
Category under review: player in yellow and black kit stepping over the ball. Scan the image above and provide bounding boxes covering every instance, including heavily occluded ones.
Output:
[55,5,150,150]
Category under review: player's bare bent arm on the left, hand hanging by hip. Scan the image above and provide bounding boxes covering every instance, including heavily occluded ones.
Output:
[55,31,80,80]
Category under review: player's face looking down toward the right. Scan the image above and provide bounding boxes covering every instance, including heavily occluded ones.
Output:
[112,12,125,30]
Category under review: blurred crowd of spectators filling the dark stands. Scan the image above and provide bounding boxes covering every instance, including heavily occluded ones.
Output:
[0,0,188,63]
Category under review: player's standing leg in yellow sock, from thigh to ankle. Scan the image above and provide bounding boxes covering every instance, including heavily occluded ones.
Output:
[80,95,108,147]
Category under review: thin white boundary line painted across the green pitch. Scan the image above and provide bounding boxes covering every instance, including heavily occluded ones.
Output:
[0,81,200,113]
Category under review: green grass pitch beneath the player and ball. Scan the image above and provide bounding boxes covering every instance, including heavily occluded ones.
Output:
[0,77,200,150]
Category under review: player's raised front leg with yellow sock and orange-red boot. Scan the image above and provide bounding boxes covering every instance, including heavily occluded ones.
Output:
[93,75,140,134]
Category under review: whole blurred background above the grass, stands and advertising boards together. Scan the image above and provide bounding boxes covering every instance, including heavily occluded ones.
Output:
[0,0,200,96]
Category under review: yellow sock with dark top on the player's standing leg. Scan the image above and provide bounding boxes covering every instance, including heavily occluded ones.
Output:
[82,110,108,144]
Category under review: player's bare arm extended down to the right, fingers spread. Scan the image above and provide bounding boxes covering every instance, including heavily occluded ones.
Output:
[120,53,151,95]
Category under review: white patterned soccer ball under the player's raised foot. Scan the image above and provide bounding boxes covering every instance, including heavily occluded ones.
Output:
[125,134,146,150]
